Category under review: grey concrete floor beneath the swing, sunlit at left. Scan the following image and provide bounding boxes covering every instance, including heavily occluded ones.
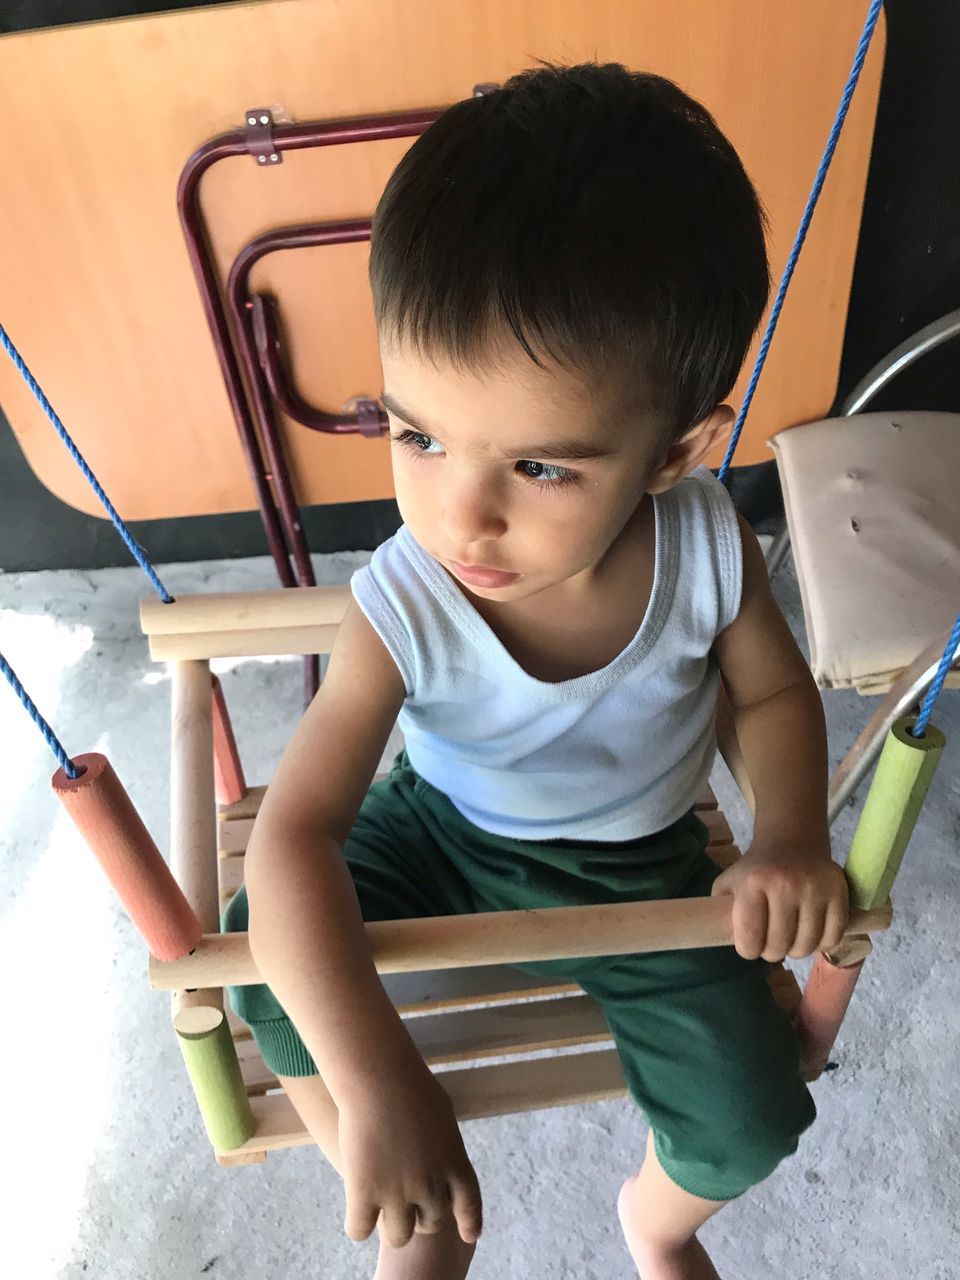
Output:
[0,556,960,1280]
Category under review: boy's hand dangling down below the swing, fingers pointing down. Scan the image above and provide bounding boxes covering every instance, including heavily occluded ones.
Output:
[339,1061,483,1248]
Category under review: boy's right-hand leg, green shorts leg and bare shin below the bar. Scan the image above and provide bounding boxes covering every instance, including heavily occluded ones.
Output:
[579,931,814,1280]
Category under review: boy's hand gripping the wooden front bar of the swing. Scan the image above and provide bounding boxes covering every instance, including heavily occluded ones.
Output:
[712,840,849,963]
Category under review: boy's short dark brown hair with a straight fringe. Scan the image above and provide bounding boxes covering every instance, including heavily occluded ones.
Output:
[370,63,769,435]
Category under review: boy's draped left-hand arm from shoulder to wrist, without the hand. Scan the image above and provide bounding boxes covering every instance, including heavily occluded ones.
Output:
[244,603,408,1102]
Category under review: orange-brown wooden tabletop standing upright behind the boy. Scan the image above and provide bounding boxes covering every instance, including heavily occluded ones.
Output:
[0,0,883,519]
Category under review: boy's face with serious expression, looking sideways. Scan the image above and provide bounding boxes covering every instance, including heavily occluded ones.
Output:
[380,339,727,600]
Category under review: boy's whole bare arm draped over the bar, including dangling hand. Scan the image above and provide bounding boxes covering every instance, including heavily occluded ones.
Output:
[246,603,483,1248]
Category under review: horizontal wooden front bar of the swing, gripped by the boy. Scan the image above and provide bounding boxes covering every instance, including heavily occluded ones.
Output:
[150,897,892,991]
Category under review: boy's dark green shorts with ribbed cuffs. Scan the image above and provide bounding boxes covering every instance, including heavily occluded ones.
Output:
[223,754,815,1201]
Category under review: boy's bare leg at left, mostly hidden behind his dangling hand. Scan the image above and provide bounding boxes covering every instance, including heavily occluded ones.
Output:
[278,1075,476,1280]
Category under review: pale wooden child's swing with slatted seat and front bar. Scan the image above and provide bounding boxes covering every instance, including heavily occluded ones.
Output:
[126,588,901,1165]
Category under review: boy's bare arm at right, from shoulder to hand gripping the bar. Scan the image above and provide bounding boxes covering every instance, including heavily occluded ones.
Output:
[713,518,847,961]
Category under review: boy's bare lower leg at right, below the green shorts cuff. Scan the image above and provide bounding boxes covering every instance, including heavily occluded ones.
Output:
[617,1133,727,1280]
